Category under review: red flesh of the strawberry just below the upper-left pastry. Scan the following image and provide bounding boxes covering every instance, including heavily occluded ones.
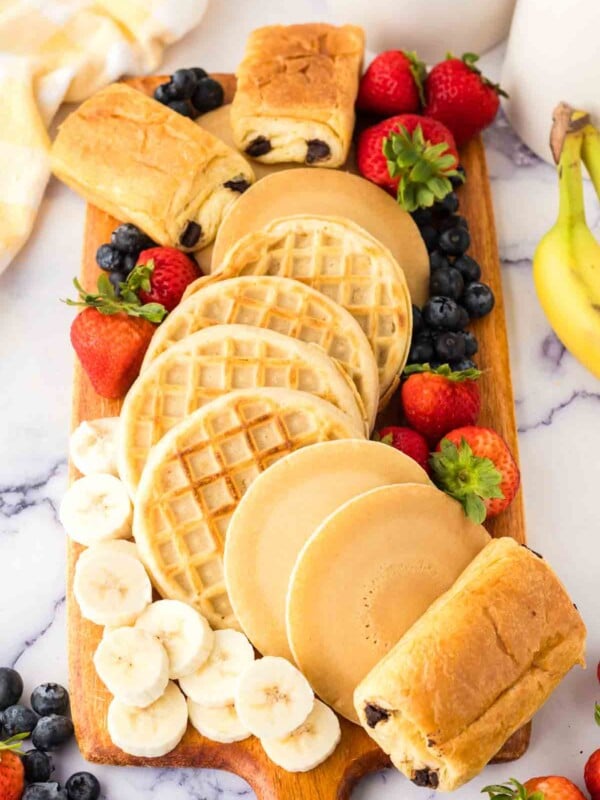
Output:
[136,247,200,311]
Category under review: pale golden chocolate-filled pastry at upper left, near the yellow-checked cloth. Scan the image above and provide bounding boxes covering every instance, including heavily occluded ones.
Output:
[51,83,254,250]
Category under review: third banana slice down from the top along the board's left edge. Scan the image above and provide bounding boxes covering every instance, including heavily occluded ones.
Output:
[73,547,152,628]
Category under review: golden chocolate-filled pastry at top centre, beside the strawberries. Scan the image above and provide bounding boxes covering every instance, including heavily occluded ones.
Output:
[231,23,364,167]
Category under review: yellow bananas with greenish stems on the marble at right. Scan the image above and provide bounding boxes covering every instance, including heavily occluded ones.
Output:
[533,103,600,377]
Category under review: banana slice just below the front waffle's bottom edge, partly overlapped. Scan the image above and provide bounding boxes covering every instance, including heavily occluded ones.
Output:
[135,600,214,680]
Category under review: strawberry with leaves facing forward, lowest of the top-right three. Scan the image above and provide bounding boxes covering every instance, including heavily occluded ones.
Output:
[356,114,461,211]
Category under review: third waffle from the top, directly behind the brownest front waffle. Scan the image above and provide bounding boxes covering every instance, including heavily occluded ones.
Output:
[119,325,368,497]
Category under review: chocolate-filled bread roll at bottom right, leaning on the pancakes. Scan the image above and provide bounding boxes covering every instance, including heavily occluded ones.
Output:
[354,538,585,791]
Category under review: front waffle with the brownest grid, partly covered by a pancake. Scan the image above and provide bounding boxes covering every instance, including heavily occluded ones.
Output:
[133,389,364,628]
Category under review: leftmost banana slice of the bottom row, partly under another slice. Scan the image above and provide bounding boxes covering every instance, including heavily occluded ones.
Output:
[107,682,188,758]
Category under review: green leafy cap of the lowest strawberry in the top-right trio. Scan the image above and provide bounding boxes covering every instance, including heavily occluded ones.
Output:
[383,125,466,211]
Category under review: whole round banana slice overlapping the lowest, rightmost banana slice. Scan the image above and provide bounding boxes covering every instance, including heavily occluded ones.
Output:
[235,656,315,739]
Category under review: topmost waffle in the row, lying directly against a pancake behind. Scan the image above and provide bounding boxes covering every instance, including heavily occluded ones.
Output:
[188,215,412,405]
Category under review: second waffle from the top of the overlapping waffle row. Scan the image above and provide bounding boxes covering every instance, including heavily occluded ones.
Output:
[142,277,379,427]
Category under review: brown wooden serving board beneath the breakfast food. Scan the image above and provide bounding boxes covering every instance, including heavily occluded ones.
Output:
[67,75,530,800]
